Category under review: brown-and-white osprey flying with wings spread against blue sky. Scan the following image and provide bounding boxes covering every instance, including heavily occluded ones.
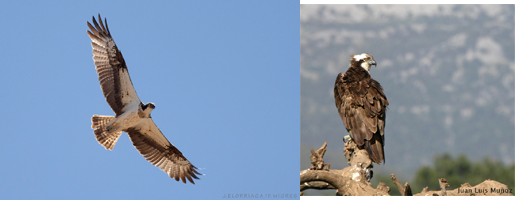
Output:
[88,14,200,184]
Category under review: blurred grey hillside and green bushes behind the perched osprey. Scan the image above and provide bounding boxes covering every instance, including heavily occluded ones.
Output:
[300,5,515,195]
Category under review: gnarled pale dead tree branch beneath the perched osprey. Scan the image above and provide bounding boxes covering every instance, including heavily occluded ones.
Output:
[300,140,512,196]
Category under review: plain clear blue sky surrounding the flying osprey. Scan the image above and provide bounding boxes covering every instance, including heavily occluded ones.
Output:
[0,1,300,199]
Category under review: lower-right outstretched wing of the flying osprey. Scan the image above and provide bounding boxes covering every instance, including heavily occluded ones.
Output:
[126,118,200,184]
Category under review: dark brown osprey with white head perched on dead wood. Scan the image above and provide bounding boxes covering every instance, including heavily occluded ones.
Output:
[334,53,388,164]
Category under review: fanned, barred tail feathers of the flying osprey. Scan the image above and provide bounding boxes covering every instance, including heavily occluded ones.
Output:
[91,115,122,150]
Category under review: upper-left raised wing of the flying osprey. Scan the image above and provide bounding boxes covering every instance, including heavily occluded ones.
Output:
[88,14,141,116]
